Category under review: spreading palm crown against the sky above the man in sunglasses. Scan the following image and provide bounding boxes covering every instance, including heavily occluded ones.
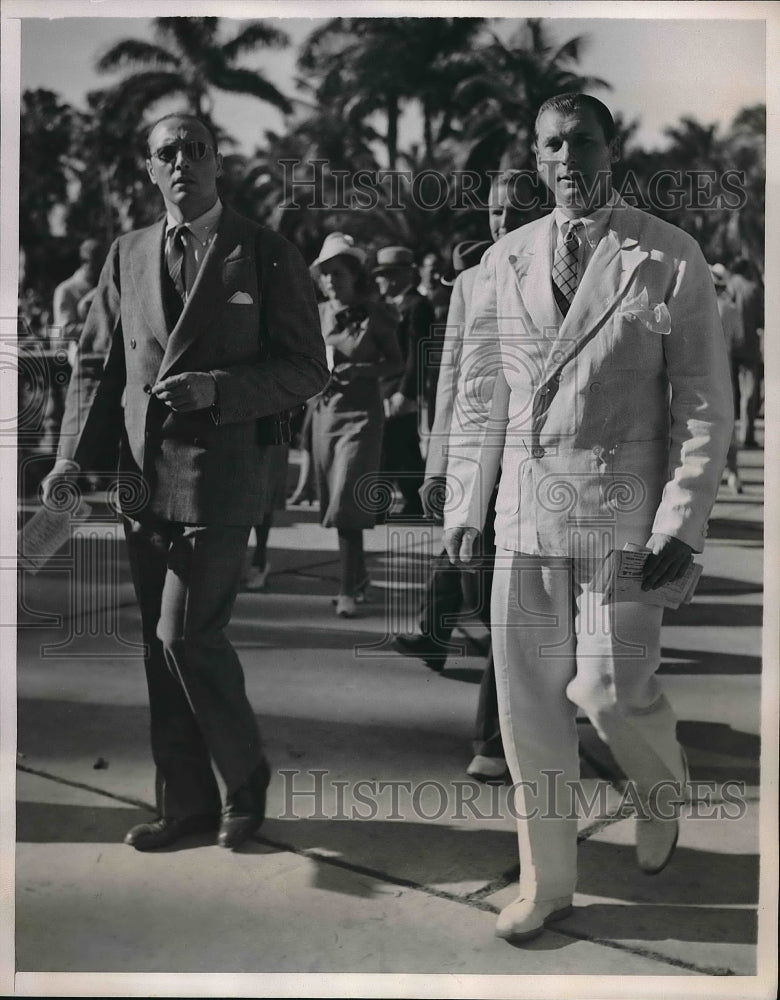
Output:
[97,17,292,135]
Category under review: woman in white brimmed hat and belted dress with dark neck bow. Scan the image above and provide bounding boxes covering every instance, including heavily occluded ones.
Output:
[312,233,402,618]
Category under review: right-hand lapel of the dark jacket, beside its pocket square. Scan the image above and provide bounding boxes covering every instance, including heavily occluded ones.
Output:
[159,207,246,379]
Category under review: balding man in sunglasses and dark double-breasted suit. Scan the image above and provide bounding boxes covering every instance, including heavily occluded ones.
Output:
[44,114,327,850]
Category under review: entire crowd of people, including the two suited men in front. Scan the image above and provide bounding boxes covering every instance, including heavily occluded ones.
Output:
[21,95,763,940]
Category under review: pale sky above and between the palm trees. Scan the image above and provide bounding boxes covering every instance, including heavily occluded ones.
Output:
[15,11,765,153]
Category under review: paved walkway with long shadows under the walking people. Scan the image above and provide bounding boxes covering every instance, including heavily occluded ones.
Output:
[7,436,769,997]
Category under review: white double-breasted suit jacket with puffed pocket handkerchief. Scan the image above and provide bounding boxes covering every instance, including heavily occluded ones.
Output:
[445,199,733,556]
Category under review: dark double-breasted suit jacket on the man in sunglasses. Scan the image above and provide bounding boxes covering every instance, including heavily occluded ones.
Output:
[59,206,328,525]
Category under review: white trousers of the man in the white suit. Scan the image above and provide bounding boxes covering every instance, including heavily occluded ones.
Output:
[491,549,684,899]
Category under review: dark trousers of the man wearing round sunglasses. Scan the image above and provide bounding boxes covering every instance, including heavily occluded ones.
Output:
[125,518,264,817]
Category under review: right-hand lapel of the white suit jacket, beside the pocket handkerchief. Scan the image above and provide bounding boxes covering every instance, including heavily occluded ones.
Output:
[545,218,648,377]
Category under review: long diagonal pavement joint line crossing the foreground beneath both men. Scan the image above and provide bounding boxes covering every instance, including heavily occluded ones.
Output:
[16,762,748,976]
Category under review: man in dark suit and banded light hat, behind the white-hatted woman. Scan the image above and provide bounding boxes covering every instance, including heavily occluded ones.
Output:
[373,246,434,517]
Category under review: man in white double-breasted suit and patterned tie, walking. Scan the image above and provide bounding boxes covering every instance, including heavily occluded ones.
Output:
[445,94,733,940]
